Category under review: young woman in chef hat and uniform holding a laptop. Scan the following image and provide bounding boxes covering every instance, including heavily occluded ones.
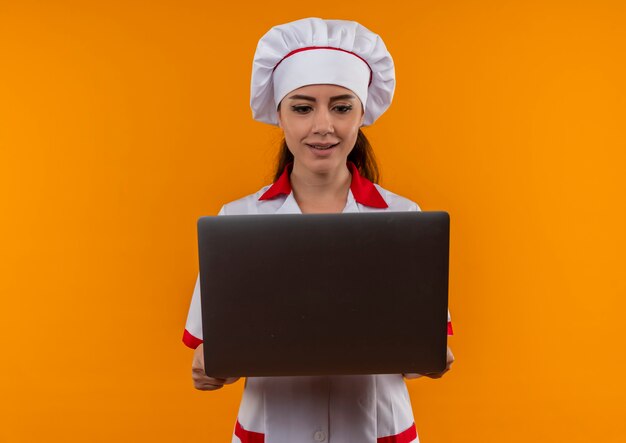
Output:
[183,18,454,443]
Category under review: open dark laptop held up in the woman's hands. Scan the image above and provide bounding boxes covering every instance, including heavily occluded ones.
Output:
[198,212,450,377]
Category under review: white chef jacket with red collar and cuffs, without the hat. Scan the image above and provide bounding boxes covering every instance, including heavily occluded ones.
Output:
[183,163,452,443]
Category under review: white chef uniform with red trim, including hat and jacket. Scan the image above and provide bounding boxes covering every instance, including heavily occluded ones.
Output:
[183,18,452,443]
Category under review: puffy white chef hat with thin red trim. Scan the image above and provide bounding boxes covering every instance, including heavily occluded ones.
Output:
[250,18,396,126]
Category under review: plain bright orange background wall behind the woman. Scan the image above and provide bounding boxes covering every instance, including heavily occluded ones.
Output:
[0,0,626,443]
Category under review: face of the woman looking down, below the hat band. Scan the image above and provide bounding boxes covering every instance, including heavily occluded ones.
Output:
[278,85,364,173]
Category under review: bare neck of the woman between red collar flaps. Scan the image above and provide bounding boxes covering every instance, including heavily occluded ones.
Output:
[289,162,352,212]
